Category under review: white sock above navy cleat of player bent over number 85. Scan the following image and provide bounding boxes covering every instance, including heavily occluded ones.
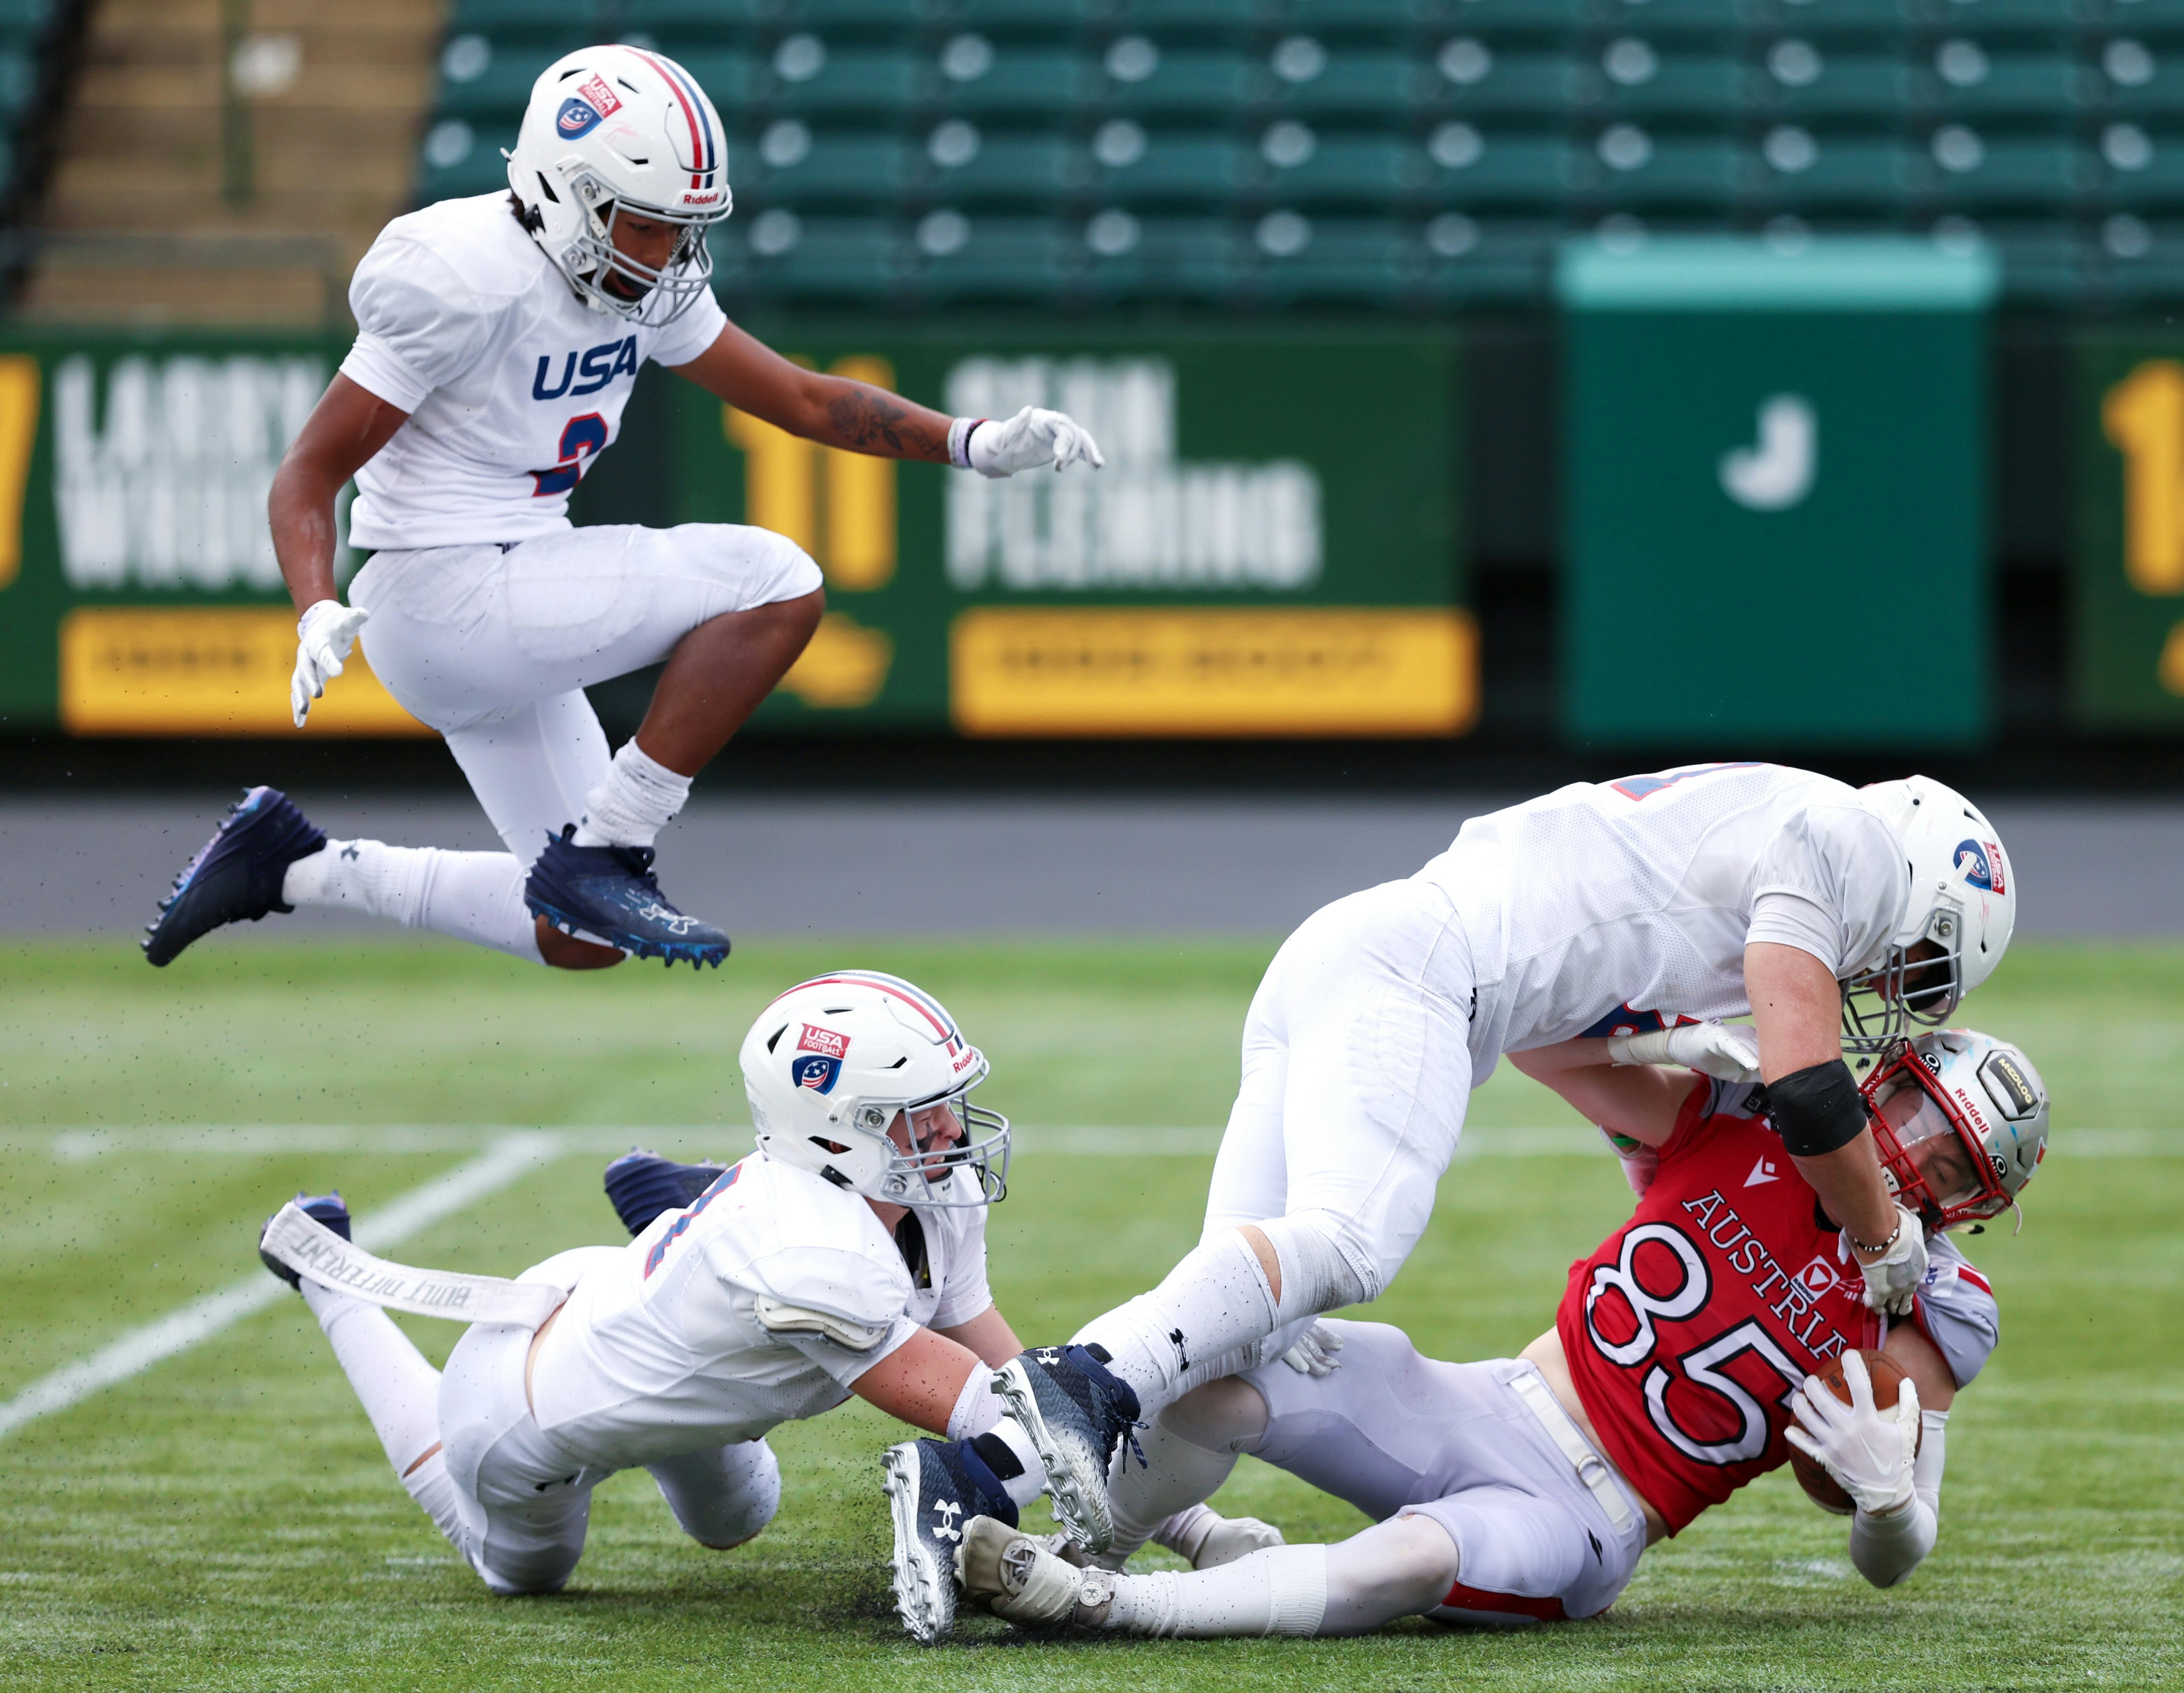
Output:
[1070,1230,1280,1422]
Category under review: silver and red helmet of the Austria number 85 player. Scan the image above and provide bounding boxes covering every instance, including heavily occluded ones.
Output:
[1861,1029,2048,1230]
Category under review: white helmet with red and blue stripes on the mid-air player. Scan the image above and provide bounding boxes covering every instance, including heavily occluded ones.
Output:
[507,46,732,328]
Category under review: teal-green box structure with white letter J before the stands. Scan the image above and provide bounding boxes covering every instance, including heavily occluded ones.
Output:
[1555,238,1998,749]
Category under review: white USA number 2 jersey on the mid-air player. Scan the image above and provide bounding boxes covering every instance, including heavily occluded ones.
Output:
[341,192,727,548]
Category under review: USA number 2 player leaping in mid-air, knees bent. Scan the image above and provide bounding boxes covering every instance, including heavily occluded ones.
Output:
[144,46,1101,970]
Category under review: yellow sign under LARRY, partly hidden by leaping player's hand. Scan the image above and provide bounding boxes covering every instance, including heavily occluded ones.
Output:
[61,605,433,736]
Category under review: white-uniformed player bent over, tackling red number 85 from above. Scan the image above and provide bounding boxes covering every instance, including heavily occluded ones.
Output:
[974,765,2016,1551]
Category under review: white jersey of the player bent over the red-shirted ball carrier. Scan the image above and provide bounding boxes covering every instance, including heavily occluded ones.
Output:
[1418,765,1911,1057]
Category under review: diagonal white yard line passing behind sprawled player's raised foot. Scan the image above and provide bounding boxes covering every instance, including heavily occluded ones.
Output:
[0,1132,570,1435]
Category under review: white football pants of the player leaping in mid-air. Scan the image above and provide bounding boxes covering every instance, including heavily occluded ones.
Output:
[349,524,819,869]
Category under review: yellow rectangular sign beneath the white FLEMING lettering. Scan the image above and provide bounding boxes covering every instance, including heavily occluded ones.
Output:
[948,607,1479,736]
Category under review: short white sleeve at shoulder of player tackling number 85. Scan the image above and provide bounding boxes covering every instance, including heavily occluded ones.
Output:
[1745,806,1911,981]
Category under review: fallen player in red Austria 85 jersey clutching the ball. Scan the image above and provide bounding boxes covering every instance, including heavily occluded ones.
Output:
[956,1029,2046,1634]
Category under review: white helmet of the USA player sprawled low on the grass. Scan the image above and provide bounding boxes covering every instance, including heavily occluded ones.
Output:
[738,970,1009,1206]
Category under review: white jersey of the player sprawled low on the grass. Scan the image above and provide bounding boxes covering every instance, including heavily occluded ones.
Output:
[530,1151,994,1468]
